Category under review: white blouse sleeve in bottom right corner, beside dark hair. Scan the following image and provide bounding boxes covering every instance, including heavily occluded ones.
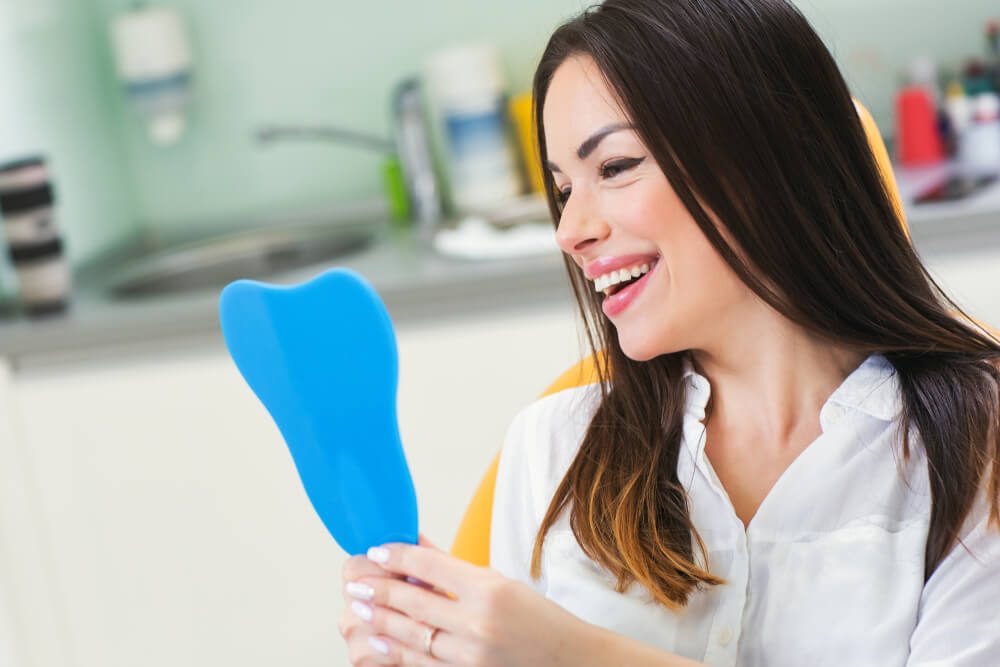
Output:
[906,496,1000,667]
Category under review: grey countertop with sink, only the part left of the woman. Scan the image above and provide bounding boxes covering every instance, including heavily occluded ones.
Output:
[0,219,572,363]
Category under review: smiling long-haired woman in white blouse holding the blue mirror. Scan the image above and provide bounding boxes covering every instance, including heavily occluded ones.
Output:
[341,0,1000,667]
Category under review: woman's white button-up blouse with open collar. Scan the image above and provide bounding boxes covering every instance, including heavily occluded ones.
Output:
[490,355,1000,667]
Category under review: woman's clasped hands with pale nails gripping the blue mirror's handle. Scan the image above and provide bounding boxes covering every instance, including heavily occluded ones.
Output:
[341,540,596,667]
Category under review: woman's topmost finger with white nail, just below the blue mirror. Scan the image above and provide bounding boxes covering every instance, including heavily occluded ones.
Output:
[368,543,486,598]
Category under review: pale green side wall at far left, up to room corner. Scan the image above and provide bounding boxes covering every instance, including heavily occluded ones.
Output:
[0,0,137,266]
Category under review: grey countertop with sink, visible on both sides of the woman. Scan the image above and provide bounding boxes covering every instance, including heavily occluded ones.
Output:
[0,170,1000,365]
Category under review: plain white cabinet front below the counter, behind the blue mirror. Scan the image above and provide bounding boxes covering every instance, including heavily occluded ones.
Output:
[0,305,580,667]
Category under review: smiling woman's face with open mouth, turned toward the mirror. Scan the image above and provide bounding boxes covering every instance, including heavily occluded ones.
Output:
[543,56,752,361]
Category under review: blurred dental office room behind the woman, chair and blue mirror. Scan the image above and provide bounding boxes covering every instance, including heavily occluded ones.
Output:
[0,0,1000,667]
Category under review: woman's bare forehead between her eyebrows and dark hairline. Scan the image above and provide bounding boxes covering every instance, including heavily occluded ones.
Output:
[542,56,628,151]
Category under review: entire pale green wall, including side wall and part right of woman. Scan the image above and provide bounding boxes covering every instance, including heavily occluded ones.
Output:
[0,0,1000,272]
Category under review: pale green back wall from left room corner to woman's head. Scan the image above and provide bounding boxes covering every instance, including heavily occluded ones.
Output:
[87,0,579,235]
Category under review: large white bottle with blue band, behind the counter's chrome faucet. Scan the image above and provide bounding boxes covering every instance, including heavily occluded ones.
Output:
[426,45,523,213]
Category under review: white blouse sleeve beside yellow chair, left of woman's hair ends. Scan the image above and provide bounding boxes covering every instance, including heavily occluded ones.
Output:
[490,408,544,592]
